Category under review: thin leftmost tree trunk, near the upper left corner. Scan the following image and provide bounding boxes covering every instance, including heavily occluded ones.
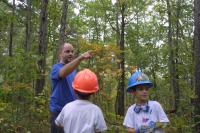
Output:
[8,0,15,57]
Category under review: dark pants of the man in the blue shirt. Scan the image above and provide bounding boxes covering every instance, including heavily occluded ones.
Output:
[50,112,64,133]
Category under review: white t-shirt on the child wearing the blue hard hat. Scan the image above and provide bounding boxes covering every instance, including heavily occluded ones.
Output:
[123,101,169,133]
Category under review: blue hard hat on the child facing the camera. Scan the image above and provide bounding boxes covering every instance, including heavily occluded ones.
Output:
[127,69,153,92]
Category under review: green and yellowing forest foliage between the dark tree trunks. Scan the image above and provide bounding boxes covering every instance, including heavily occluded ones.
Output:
[0,0,198,133]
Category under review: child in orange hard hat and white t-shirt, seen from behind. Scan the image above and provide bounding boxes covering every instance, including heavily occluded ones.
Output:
[55,69,107,133]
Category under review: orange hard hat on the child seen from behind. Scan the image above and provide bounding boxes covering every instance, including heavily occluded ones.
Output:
[72,69,99,93]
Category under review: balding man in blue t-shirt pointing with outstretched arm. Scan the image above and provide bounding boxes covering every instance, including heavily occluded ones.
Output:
[50,43,92,133]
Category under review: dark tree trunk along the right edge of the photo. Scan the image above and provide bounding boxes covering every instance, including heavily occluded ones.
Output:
[194,0,200,132]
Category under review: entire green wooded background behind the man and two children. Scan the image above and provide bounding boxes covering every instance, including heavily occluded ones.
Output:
[0,0,200,133]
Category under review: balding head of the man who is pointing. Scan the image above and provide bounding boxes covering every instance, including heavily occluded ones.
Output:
[59,43,74,64]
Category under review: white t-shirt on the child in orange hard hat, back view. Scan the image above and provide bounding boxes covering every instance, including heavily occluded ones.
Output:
[55,100,107,133]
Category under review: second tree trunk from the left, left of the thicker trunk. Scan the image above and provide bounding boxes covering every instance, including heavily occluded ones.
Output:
[24,0,32,51]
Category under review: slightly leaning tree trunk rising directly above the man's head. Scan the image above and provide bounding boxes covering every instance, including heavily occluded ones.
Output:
[60,0,69,45]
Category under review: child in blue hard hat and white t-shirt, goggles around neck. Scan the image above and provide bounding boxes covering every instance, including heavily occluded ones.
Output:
[123,69,169,133]
